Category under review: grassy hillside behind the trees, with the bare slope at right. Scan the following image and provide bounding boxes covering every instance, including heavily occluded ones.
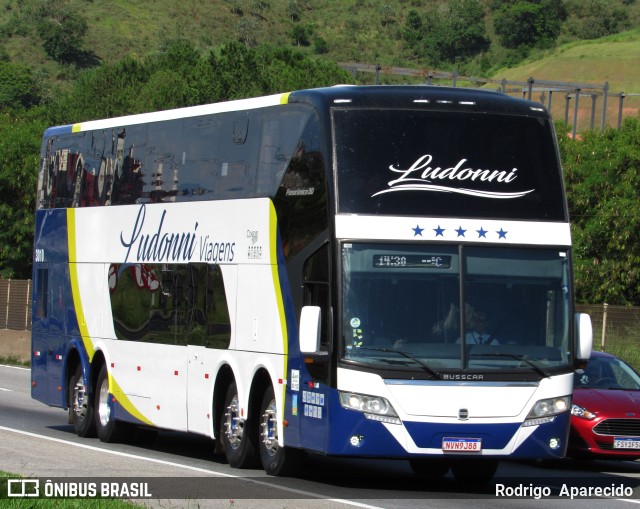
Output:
[0,0,640,127]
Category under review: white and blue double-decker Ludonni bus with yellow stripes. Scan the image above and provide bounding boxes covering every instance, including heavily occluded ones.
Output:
[32,86,591,480]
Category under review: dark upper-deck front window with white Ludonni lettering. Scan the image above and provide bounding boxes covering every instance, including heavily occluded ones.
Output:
[333,108,567,221]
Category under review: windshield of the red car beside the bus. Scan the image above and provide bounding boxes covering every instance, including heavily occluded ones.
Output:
[574,357,640,391]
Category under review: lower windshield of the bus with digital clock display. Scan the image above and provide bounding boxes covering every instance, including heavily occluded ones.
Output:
[342,242,572,377]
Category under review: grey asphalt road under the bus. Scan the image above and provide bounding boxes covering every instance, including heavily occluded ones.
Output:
[0,366,640,509]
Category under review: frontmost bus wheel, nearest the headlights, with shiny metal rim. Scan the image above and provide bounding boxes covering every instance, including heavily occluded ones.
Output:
[258,386,304,476]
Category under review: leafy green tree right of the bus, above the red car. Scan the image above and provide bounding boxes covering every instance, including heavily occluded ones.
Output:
[558,117,640,305]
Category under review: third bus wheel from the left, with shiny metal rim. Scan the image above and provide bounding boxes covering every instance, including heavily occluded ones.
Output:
[220,382,258,468]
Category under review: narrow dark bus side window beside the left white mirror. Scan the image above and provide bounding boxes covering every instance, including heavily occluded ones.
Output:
[302,244,331,351]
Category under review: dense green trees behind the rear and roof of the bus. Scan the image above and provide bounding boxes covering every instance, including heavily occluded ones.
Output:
[0,40,350,278]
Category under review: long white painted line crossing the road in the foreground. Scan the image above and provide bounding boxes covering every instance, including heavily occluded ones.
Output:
[0,426,382,509]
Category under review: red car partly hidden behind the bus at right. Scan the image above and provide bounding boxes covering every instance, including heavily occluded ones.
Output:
[567,352,640,460]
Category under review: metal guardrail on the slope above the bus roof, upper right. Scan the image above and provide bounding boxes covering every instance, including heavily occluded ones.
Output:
[338,63,640,139]
